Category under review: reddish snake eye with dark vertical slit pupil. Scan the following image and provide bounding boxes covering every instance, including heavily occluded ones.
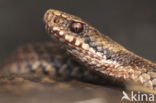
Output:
[70,22,83,33]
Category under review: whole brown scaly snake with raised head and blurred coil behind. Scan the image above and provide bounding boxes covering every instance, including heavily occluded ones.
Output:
[0,9,156,90]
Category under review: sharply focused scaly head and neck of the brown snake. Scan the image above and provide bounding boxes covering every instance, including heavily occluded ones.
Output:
[44,9,156,89]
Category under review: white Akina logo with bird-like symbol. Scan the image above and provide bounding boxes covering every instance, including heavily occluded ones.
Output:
[121,91,154,102]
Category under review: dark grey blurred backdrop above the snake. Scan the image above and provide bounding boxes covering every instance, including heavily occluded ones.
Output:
[0,0,156,62]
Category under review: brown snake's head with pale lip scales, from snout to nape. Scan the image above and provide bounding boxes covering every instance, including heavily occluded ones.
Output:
[44,9,127,67]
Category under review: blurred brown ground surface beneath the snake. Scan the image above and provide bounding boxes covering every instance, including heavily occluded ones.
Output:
[0,78,133,103]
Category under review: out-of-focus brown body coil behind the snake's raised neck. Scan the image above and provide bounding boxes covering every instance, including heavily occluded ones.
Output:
[1,42,101,83]
